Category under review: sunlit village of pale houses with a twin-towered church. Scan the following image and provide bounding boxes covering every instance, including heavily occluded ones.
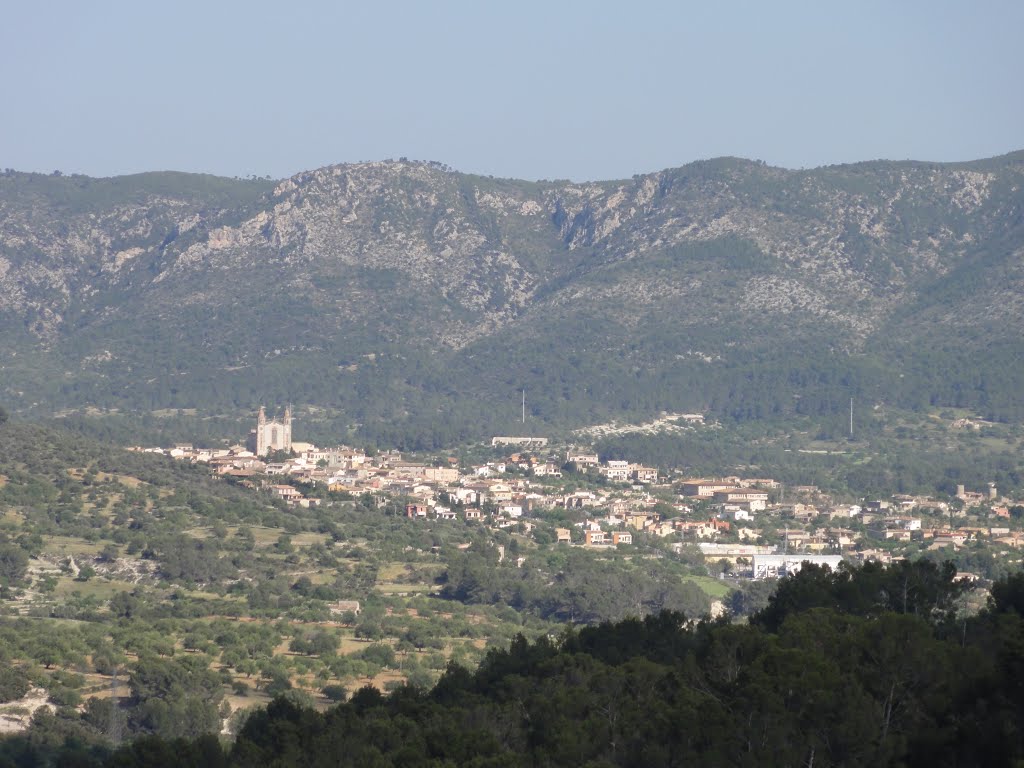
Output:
[134,410,1024,579]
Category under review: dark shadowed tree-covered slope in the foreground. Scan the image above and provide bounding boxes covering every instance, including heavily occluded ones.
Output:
[6,561,1024,768]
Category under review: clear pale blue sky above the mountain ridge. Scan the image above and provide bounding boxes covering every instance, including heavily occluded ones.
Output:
[0,0,1024,181]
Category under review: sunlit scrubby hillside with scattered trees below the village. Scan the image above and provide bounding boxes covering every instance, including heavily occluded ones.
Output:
[0,422,721,753]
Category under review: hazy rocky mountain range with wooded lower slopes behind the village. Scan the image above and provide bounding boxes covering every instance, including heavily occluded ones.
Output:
[0,153,1024,444]
